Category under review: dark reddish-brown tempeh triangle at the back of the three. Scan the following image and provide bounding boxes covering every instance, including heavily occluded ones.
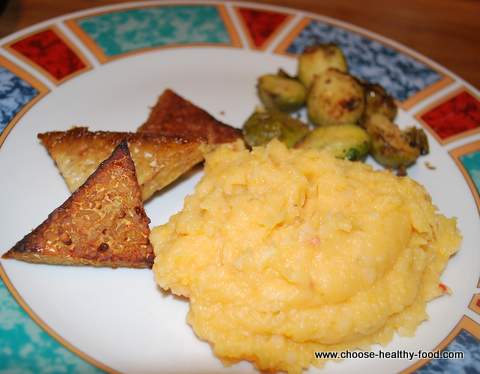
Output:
[138,89,242,144]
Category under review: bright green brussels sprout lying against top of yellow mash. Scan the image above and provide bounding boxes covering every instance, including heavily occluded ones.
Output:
[295,125,370,161]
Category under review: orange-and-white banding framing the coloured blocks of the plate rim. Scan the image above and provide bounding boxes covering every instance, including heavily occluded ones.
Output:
[0,0,480,373]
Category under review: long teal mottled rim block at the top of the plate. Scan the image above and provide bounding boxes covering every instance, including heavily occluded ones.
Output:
[77,5,230,56]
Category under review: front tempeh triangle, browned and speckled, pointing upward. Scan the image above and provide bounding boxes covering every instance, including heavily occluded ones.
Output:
[3,141,154,268]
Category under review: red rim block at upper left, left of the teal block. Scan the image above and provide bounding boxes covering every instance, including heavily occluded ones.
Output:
[10,29,86,80]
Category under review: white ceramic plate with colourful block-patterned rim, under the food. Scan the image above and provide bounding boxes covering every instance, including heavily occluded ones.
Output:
[0,2,480,373]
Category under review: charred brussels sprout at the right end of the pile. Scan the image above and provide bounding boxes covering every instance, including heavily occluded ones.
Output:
[365,114,420,169]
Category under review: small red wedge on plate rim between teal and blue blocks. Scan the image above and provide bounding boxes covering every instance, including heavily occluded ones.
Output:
[238,8,287,48]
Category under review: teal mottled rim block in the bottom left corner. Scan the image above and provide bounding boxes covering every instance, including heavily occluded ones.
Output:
[0,280,102,374]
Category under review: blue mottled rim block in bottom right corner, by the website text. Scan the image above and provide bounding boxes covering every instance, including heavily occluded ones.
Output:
[416,330,480,374]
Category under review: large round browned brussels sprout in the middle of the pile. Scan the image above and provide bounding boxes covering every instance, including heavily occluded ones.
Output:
[307,69,365,126]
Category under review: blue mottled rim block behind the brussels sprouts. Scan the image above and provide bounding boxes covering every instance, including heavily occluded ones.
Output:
[287,21,441,101]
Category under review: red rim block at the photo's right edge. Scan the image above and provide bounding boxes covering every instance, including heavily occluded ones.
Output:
[421,91,480,140]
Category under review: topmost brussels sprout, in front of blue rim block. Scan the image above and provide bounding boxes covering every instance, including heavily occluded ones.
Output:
[297,44,348,88]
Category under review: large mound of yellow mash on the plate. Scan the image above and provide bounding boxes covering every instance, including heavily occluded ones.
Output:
[151,141,460,373]
